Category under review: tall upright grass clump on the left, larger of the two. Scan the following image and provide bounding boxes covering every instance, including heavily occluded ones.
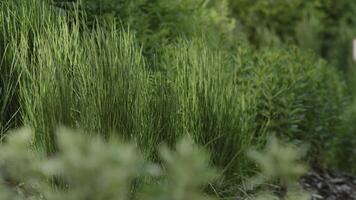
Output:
[1,1,149,152]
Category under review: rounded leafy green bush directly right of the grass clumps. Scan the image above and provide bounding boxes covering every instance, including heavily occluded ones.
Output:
[253,48,345,153]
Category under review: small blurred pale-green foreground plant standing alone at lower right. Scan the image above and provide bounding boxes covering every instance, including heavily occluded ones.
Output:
[248,137,311,200]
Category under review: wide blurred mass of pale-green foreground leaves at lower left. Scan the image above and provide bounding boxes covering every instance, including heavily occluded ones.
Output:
[0,129,215,200]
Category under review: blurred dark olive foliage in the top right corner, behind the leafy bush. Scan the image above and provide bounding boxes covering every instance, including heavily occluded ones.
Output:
[230,0,356,71]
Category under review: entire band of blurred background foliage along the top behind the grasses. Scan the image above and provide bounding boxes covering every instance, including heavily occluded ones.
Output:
[54,0,356,71]
